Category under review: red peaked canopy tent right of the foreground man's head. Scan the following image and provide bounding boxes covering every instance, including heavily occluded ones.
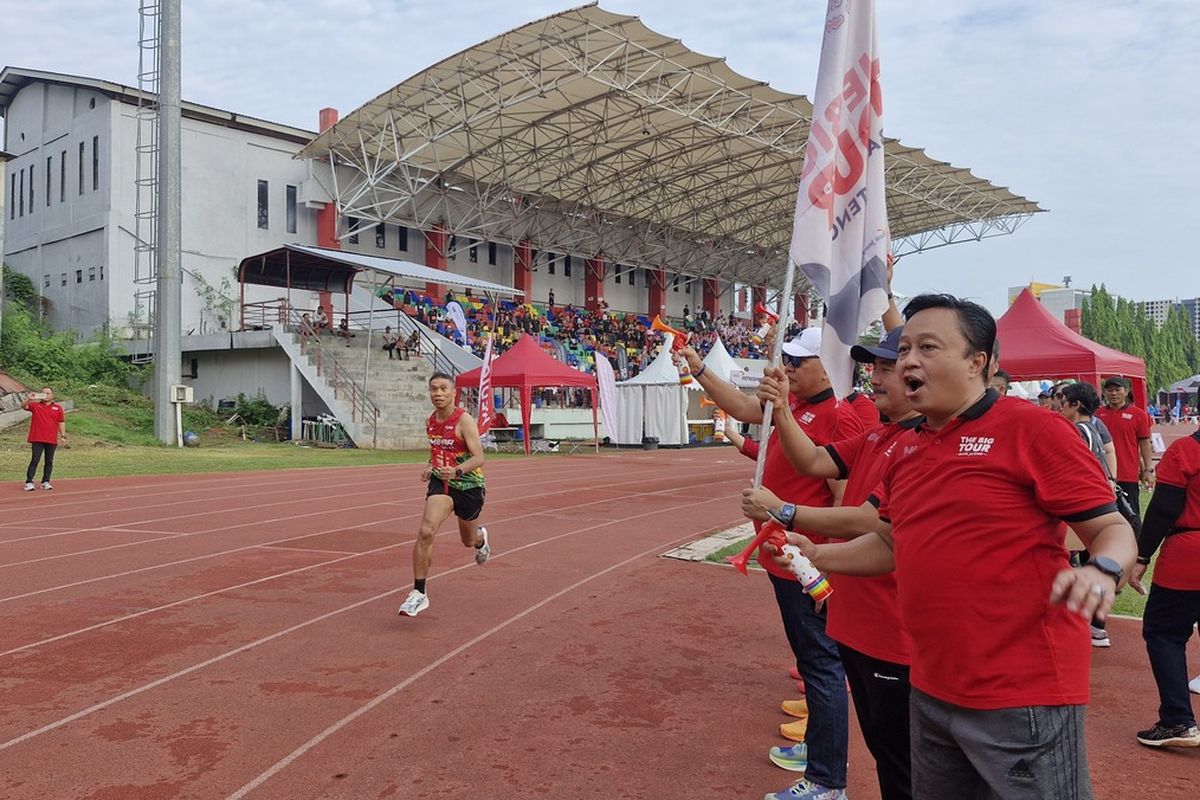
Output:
[996,289,1146,408]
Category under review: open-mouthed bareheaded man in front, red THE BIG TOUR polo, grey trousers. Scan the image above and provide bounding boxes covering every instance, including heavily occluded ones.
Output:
[768,295,1135,800]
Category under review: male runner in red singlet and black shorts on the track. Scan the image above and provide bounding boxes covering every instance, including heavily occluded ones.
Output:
[400,372,492,616]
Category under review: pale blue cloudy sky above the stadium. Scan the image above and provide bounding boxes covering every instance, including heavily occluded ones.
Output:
[0,0,1200,312]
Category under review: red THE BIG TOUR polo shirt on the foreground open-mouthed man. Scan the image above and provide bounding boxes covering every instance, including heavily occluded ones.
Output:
[873,390,1116,709]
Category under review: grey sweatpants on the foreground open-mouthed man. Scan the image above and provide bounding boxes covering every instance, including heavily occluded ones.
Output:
[910,688,1092,800]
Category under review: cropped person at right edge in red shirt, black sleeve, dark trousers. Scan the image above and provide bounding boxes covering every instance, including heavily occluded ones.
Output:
[1130,433,1200,747]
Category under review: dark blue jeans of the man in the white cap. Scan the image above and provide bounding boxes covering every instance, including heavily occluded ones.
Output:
[770,576,850,789]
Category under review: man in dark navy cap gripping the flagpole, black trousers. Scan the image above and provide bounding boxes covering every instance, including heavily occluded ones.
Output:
[742,327,920,800]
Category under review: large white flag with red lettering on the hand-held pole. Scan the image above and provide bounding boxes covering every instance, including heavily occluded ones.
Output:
[790,0,890,397]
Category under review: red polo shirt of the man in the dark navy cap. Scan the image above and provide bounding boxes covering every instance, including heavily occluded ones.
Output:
[826,417,920,664]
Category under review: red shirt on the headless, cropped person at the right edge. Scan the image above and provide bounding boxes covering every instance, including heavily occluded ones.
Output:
[1154,435,1200,591]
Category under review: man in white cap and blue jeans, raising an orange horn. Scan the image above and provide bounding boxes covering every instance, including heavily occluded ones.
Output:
[682,327,863,800]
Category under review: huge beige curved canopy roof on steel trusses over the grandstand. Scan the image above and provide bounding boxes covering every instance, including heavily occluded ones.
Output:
[299,5,1040,287]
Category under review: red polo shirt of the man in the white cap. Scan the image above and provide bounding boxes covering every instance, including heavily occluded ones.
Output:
[742,389,863,581]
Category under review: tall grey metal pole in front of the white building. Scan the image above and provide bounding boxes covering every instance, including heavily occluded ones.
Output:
[154,0,182,444]
